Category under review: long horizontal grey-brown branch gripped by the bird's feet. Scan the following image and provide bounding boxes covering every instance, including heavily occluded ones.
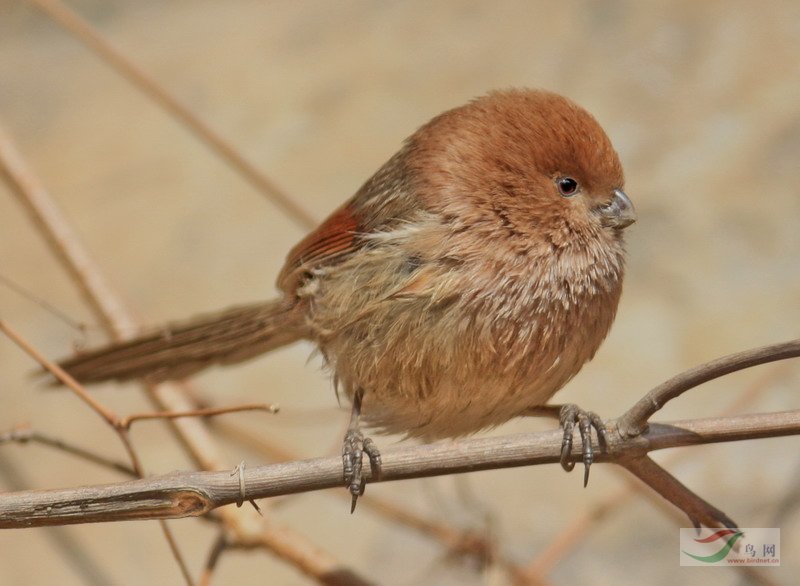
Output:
[0,410,800,528]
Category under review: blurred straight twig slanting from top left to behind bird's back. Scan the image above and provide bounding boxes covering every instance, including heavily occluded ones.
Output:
[23,0,317,230]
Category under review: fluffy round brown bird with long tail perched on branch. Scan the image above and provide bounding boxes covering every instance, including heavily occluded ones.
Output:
[56,90,635,501]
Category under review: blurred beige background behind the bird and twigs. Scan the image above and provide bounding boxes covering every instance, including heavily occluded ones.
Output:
[0,0,800,585]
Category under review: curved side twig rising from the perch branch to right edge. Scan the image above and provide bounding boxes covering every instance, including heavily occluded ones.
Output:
[617,339,800,437]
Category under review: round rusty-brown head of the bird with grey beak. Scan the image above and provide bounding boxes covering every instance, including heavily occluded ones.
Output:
[409,90,636,249]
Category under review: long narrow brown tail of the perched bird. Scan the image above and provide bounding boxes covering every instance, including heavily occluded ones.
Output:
[59,299,307,382]
